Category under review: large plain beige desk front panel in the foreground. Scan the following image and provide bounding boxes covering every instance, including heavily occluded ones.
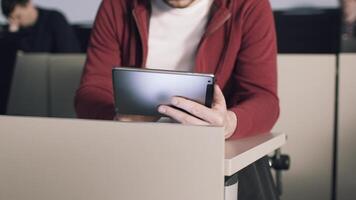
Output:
[0,117,224,200]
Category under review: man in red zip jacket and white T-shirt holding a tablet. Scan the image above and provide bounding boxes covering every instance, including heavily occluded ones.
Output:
[75,0,279,139]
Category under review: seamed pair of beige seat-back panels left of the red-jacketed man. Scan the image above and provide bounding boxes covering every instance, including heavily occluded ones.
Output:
[7,53,85,118]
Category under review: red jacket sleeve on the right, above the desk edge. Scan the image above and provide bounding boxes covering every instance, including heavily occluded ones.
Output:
[229,0,279,139]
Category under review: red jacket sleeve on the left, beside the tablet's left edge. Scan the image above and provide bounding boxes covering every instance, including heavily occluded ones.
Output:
[75,0,121,120]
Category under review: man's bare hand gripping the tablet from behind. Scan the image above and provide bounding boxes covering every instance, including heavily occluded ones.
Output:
[158,85,237,139]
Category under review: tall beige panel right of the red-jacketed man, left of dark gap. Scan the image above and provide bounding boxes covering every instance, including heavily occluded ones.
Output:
[273,55,336,200]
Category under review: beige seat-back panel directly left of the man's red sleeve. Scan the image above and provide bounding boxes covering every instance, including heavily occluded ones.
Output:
[49,54,85,118]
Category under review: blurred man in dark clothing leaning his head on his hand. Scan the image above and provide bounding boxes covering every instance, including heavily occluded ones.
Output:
[1,0,80,53]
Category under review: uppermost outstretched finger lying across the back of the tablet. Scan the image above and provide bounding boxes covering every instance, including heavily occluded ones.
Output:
[171,97,221,124]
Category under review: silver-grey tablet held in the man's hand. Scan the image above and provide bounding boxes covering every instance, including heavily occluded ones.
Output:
[112,67,215,116]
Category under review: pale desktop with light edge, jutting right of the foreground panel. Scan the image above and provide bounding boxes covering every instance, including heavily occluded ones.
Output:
[225,133,287,176]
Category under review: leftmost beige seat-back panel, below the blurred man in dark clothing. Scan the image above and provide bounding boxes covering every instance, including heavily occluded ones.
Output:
[7,54,49,116]
